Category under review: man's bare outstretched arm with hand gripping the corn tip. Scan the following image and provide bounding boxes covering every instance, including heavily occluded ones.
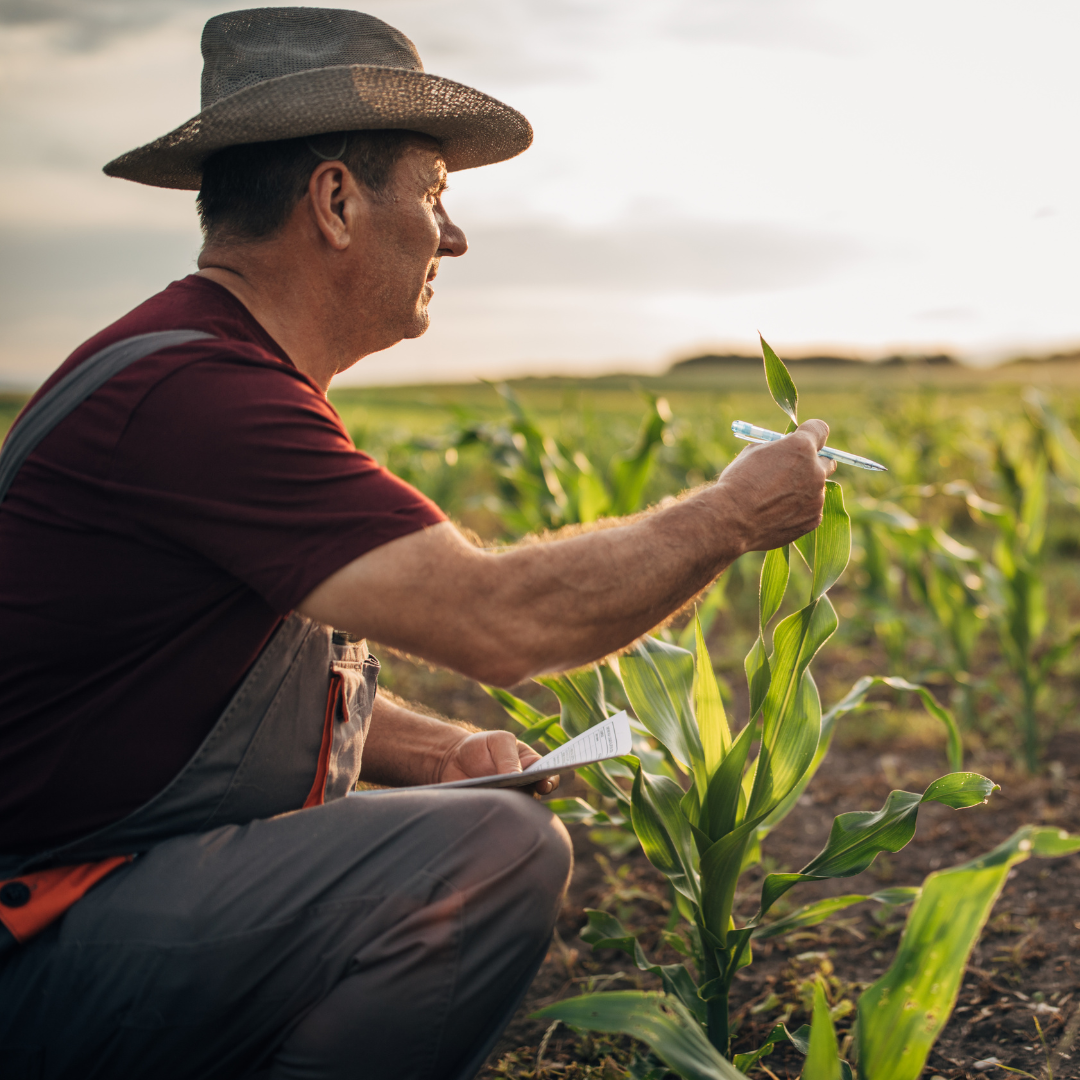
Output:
[300,420,835,686]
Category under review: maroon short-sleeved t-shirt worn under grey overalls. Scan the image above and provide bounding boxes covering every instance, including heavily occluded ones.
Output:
[0,276,445,852]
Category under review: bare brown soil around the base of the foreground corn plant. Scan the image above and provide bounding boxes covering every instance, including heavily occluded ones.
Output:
[481,733,1080,1080]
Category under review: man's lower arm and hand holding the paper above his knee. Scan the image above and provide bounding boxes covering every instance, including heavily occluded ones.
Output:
[360,690,558,795]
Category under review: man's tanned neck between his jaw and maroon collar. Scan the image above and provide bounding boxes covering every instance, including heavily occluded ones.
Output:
[198,244,345,393]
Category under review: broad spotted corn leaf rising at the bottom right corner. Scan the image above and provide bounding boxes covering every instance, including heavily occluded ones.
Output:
[856,825,1080,1080]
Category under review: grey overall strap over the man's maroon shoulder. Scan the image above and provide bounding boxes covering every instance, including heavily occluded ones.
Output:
[0,330,214,502]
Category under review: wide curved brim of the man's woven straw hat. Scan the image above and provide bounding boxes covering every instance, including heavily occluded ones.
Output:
[105,64,532,191]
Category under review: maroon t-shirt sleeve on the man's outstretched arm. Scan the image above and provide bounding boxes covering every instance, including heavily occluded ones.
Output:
[110,346,446,615]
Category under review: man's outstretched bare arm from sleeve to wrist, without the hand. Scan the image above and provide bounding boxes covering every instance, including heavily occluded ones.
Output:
[311,491,742,686]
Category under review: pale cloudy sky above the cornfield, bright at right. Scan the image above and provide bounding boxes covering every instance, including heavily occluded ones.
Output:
[0,0,1080,387]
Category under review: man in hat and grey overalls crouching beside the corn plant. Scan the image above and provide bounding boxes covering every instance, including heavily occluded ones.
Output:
[0,9,832,1080]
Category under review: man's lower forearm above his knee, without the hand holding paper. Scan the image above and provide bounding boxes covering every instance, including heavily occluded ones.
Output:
[360,690,470,787]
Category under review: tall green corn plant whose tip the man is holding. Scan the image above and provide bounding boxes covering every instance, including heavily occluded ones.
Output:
[492,342,996,1076]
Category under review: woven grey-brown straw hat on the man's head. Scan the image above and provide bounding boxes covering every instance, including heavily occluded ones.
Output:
[105,8,532,190]
